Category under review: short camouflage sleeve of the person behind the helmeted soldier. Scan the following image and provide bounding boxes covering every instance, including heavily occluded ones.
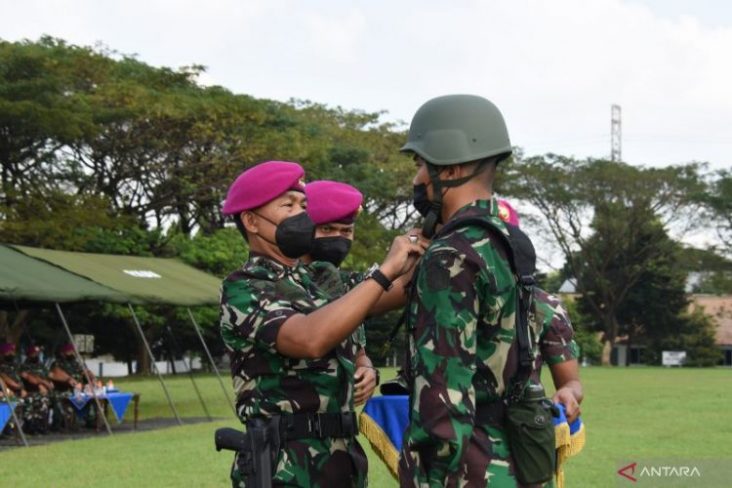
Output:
[534,290,579,366]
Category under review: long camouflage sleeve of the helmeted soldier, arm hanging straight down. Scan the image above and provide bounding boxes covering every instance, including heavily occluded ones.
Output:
[408,249,478,486]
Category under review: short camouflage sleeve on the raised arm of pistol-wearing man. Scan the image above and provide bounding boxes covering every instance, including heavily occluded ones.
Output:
[220,280,298,353]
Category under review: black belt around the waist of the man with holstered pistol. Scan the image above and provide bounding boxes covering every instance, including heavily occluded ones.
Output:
[280,412,358,440]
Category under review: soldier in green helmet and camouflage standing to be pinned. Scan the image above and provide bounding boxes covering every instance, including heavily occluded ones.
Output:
[399,95,533,487]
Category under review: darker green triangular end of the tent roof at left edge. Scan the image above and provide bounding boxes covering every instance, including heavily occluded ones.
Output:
[0,245,130,303]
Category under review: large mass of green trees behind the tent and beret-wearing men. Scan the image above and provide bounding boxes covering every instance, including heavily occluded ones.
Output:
[0,37,413,374]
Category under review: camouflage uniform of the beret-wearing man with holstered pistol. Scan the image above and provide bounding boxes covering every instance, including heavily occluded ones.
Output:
[221,254,366,488]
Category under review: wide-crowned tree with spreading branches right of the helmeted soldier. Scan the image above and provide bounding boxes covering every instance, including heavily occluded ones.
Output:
[503,154,704,364]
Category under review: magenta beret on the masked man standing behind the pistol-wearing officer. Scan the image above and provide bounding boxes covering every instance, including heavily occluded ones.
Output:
[305,180,363,225]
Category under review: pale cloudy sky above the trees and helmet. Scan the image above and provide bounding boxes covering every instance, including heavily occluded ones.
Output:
[0,0,732,173]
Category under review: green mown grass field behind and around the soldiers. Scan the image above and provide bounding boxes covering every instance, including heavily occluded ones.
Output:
[0,367,732,488]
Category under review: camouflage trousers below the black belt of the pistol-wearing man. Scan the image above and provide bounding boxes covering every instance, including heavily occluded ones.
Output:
[231,438,368,488]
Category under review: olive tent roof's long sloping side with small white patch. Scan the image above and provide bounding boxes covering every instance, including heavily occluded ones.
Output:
[13,246,221,306]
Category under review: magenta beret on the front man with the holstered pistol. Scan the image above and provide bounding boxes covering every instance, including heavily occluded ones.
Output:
[222,161,305,215]
